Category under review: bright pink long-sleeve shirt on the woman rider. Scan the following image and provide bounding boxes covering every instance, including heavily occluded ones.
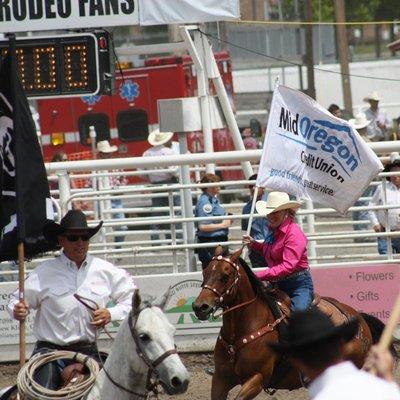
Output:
[251,218,309,281]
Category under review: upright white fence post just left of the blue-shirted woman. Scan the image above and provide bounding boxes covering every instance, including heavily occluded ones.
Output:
[178,132,196,271]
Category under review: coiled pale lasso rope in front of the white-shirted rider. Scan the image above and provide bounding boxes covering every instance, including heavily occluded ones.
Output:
[17,351,99,400]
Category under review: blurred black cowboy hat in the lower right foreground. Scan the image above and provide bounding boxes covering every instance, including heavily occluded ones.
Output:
[268,307,358,353]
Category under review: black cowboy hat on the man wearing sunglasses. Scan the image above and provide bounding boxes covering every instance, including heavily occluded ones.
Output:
[43,210,103,243]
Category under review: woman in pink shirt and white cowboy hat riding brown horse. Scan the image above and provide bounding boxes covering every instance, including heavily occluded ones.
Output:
[243,192,314,311]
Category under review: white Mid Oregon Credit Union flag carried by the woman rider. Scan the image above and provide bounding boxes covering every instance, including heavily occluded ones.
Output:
[257,85,383,213]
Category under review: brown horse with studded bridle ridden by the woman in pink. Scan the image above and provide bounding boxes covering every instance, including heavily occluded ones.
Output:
[193,246,384,400]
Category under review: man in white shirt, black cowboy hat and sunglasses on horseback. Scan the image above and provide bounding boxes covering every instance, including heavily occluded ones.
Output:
[8,210,136,388]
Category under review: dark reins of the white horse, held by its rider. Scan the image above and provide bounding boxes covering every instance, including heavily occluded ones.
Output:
[74,293,178,399]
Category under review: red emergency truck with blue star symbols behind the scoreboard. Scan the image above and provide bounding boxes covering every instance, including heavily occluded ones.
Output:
[38,52,237,179]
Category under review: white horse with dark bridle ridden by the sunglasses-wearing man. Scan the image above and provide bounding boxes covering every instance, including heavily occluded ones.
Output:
[0,290,189,400]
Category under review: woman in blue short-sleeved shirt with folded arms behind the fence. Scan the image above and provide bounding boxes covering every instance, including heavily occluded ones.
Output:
[195,173,232,269]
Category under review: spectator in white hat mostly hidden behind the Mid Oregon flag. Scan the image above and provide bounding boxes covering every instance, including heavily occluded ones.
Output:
[349,113,374,236]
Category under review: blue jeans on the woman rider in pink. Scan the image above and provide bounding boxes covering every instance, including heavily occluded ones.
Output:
[277,271,314,311]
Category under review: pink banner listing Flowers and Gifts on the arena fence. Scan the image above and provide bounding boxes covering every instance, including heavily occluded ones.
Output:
[311,264,400,322]
